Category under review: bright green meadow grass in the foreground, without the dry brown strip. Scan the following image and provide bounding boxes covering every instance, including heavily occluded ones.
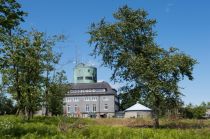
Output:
[0,116,210,139]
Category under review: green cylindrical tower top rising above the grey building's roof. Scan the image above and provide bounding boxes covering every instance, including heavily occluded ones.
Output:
[74,63,97,83]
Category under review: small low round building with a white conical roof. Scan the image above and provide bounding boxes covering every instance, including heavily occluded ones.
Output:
[124,102,152,118]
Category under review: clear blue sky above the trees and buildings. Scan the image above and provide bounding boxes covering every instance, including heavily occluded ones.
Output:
[18,0,210,105]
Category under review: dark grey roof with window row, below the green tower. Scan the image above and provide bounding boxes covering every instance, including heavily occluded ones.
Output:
[66,81,117,96]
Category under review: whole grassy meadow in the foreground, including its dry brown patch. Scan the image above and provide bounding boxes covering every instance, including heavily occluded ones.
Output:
[0,116,210,139]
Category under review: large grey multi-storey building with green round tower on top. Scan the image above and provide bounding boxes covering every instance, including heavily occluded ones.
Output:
[64,64,119,117]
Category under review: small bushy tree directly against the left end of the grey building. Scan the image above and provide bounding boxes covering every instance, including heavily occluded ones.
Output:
[48,71,69,115]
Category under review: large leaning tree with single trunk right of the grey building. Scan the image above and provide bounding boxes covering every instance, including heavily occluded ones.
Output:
[88,6,196,127]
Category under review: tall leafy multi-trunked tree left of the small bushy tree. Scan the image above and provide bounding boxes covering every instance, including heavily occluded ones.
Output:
[1,30,62,119]
